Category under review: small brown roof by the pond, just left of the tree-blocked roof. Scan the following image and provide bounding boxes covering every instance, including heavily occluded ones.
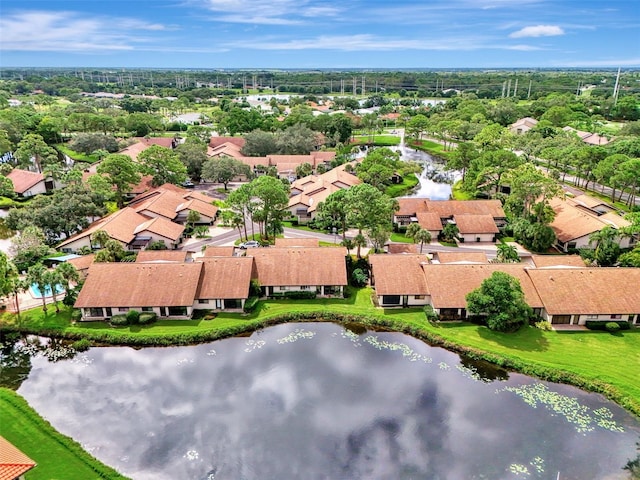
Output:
[369,254,429,295]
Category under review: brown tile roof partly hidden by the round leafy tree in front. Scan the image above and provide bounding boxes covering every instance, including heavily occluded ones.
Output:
[424,264,543,308]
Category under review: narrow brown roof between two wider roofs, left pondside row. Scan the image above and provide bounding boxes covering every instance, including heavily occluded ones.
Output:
[196,257,253,299]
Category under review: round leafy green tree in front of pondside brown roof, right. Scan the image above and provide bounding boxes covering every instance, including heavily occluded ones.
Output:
[466,271,533,332]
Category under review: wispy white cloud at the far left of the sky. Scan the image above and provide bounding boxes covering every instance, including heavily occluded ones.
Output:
[0,11,171,52]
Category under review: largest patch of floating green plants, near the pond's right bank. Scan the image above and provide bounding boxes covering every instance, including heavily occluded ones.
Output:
[499,383,624,434]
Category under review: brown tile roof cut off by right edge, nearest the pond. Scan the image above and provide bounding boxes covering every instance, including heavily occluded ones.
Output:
[529,267,640,315]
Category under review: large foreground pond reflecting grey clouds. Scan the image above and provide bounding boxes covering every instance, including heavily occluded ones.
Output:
[11,323,640,480]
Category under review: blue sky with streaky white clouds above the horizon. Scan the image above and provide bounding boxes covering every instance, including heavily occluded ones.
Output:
[0,0,640,69]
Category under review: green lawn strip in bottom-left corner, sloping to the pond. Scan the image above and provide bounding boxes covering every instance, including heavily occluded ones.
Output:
[0,388,126,480]
